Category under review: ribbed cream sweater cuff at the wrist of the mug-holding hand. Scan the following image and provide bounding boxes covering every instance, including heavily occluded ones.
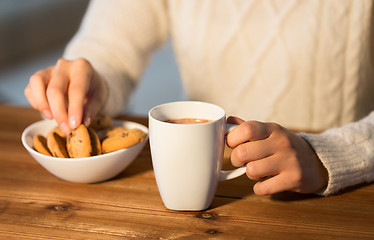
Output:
[298,132,365,196]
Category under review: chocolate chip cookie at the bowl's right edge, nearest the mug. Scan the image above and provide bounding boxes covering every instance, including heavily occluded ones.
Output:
[102,128,147,153]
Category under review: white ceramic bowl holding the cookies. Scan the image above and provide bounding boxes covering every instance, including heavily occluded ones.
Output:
[22,120,148,183]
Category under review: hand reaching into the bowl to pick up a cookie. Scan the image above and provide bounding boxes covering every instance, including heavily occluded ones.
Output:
[25,58,108,133]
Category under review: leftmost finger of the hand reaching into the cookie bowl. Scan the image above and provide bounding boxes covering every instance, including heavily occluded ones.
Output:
[25,67,53,119]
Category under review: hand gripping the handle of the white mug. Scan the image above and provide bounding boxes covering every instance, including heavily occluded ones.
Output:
[227,117,328,195]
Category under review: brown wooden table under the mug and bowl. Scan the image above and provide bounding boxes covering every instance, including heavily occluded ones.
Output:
[0,105,374,239]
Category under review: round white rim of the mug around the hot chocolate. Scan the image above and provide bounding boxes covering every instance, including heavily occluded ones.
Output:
[148,101,226,126]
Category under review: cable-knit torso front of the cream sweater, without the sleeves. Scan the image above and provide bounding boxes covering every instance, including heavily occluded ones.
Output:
[168,0,374,131]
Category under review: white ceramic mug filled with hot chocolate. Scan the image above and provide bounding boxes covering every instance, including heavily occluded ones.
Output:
[148,101,246,211]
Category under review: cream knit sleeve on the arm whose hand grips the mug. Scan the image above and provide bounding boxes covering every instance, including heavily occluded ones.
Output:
[299,112,374,196]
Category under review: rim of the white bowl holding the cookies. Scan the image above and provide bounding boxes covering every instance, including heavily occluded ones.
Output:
[21,119,149,162]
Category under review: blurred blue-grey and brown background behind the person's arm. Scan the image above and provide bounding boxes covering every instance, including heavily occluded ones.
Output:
[0,0,186,115]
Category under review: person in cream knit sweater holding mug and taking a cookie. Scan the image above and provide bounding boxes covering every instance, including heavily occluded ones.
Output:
[25,0,374,196]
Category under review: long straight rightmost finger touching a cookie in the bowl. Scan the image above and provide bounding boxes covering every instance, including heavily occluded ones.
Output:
[68,59,92,129]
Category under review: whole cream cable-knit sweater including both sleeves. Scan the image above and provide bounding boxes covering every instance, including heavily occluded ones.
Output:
[64,0,374,195]
